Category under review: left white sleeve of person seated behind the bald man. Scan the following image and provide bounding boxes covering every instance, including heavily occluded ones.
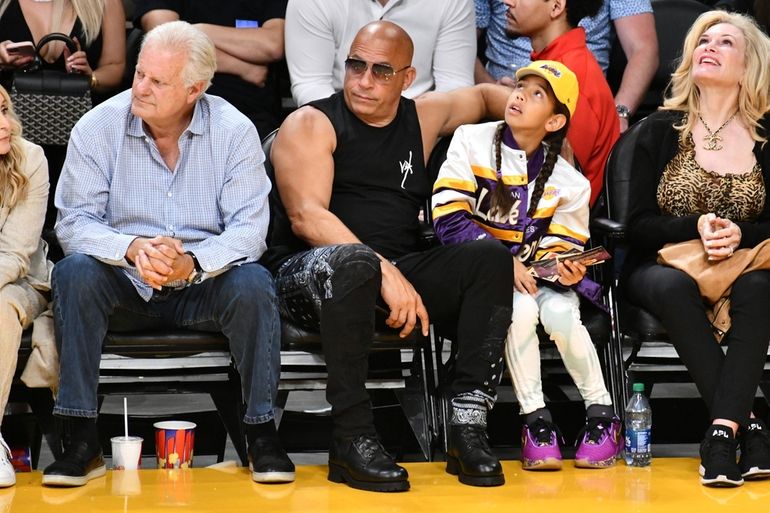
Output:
[285,0,335,106]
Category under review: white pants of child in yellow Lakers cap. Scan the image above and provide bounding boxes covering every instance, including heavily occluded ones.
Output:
[505,287,612,414]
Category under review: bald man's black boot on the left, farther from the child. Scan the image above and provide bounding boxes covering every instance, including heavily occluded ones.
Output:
[329,435,409,492]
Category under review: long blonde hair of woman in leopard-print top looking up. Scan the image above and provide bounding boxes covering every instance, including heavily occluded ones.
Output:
[661,11,770,142]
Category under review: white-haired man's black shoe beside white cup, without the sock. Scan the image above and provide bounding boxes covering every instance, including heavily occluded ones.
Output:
[43,440,107,486]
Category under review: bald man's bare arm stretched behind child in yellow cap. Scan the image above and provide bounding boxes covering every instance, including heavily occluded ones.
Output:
[415,84,511,159]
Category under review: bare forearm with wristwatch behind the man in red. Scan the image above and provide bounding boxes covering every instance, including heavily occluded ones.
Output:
[614,13,658,124]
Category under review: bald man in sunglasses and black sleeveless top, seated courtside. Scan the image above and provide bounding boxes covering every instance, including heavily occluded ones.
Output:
[266,21,513,491]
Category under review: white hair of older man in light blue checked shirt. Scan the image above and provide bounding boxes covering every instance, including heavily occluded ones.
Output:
[139,21,217,91]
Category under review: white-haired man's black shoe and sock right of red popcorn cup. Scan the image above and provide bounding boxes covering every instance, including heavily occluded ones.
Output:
[246,420,295,483]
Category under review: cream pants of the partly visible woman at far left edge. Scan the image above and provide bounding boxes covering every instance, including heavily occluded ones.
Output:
[0,280,48,423]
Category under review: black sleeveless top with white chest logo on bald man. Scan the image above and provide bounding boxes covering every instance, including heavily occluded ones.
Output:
[268,92,426,268]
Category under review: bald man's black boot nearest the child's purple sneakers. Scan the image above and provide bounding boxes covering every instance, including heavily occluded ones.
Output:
[446,424,505,486]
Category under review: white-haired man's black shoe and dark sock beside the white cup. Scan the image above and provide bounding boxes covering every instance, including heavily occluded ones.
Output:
[43,417,107,486]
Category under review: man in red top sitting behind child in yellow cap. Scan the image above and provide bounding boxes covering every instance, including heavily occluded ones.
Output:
[503,0,620,206]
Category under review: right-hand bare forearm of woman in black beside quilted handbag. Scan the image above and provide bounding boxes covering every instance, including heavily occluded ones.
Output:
[93,0,126,89]
